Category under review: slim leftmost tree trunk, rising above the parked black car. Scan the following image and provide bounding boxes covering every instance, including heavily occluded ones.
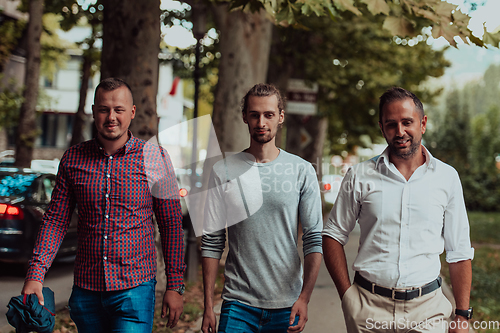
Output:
[15,0,43,167]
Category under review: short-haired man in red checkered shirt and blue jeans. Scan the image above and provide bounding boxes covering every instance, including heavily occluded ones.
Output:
[22,78,185,333]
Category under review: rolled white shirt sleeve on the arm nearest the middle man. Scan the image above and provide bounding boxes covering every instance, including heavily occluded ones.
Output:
[322,168,360,245]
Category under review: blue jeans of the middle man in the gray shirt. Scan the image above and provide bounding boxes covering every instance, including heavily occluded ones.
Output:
[217,301,299,333]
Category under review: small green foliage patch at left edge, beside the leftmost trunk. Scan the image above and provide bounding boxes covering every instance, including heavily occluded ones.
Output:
[0,75,24,128]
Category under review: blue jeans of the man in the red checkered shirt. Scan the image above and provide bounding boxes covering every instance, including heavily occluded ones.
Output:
[69,279,156,333]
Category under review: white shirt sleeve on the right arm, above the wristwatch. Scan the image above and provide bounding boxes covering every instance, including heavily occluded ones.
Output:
[443,172,474,263]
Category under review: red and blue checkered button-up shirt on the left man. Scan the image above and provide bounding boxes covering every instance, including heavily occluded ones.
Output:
[26,132,185,291]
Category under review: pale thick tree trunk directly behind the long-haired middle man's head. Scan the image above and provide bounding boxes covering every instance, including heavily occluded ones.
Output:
[212,5,272,152]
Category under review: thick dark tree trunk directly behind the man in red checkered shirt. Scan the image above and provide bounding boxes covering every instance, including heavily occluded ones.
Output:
[101,0,160,140]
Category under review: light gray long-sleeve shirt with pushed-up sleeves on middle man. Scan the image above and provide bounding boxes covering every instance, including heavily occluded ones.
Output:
[202,150,323,309]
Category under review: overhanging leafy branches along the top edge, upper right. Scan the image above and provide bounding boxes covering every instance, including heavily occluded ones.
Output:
[225,0,491,46]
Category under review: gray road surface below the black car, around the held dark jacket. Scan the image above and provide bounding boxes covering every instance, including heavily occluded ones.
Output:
[0,258,74,333]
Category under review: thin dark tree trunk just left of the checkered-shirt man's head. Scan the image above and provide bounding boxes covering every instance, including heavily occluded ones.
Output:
[70,45,93,146]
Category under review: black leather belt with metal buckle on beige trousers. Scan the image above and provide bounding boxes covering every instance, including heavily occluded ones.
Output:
[354,272,442,301]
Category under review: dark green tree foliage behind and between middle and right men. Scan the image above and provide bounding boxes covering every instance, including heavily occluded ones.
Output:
[269,8,449,153]
